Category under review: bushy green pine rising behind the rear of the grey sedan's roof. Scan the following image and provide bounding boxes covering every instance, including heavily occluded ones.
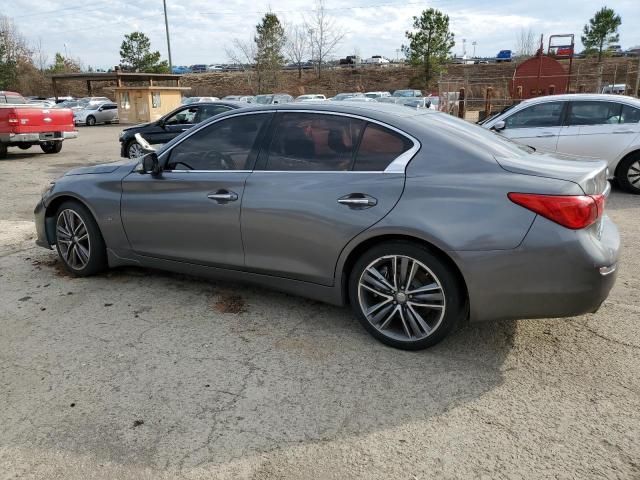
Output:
[402,8,455,87]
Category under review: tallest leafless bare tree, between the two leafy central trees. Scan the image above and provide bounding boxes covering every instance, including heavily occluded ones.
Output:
[304,0,346,78]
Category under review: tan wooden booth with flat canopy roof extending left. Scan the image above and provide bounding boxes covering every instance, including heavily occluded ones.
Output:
[51,71,190,123]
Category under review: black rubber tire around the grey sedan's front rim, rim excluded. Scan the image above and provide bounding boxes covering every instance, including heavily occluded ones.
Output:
[55,200,108,277]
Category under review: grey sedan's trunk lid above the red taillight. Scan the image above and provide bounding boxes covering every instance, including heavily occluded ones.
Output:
[496,153,608,195]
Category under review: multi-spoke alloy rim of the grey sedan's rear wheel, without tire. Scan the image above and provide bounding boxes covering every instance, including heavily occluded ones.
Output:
[358,255,446,341]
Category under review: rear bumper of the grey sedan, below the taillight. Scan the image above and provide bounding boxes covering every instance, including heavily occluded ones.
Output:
[457,216,620,321]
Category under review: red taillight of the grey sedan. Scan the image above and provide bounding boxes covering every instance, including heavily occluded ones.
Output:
[508,193,605,230]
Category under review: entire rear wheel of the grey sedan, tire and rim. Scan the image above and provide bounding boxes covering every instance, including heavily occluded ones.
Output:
[349,241,467,350]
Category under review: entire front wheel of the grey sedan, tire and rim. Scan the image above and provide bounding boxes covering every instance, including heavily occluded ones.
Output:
[56,201,107,277]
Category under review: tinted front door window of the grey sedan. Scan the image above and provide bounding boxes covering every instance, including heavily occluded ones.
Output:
[167,114,269,170]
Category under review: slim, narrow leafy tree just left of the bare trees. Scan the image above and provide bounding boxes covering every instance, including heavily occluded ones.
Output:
[254,13,286,91]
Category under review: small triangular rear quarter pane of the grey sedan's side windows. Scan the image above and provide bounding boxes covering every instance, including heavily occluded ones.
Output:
[353,123,413,171]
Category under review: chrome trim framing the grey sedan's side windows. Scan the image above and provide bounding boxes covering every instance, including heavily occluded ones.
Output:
[160,109,422,173]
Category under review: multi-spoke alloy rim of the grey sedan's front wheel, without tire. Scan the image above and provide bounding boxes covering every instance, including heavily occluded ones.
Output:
[56,209,91,270]
